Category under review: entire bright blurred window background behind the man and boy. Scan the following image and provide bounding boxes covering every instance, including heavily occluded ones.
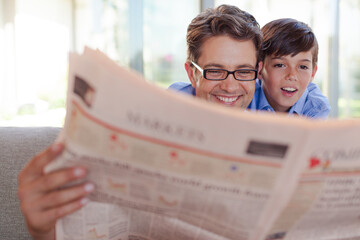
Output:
[0,0,360,126]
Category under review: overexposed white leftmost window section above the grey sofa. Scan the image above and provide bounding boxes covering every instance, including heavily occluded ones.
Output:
[0,0,71,126]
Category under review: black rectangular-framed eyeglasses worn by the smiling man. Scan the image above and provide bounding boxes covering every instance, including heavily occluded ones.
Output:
[191,61,257,81]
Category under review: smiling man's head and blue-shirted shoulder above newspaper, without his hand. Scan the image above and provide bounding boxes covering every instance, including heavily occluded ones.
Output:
[170,5,263,109]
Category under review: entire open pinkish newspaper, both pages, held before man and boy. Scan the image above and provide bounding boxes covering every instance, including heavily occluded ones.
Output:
[48,48,360,240]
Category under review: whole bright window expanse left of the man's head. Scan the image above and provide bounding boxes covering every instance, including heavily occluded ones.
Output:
[0,0,200,126]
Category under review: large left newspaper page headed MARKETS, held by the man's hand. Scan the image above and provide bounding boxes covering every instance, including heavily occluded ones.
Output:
[49,49,326,240]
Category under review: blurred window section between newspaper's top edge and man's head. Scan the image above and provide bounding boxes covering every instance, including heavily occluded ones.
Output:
[76,0,200,87]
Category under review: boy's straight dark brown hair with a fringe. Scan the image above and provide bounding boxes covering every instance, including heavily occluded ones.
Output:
[261,18,319,65]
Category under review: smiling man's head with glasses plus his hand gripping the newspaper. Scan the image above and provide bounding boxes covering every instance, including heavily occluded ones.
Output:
[18,5,262,240]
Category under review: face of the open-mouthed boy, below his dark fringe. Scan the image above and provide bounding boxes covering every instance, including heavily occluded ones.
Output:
[259,50,317,112]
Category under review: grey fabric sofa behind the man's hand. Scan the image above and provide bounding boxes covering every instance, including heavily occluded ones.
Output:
[0,127,60,240]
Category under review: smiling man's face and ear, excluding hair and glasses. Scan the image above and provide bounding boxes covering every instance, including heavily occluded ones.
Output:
[185,35,261,109]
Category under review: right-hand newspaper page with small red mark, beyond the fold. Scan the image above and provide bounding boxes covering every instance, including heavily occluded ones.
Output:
[258,120,360,240]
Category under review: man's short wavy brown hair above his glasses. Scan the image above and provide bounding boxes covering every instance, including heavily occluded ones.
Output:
[186,4,263,65]
